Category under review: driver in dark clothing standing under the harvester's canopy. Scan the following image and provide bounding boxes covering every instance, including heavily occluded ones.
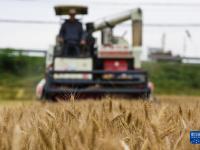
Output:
[58,9,85,56]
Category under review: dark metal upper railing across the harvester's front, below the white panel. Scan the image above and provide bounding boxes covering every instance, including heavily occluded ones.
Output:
[49,70,148,85]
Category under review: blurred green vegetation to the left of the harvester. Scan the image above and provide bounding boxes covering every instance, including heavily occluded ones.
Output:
[0,49,45,100]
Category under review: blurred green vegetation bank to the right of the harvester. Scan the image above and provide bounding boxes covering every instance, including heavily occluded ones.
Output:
[143,62,200,95]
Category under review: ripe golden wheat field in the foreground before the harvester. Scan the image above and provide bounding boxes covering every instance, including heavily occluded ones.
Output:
[0,96,200,150]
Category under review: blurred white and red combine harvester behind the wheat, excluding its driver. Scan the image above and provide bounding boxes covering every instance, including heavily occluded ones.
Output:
[36,6,153,99]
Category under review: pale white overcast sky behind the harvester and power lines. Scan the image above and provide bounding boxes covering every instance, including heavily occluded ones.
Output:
[0,0,200,57]
